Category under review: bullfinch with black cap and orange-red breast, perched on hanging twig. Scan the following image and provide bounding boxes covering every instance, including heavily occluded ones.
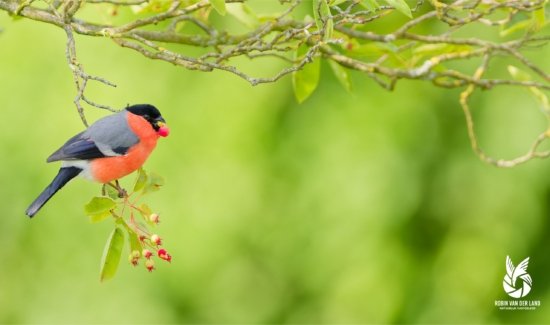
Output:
[25,104,170,218]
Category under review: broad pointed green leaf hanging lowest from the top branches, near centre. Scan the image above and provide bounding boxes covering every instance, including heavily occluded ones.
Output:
[292,45,321,103]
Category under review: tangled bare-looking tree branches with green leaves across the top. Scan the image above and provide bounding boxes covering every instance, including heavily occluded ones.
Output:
[0,0,550,167]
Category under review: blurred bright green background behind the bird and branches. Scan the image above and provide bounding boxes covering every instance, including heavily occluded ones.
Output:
[0,5,550,324]
